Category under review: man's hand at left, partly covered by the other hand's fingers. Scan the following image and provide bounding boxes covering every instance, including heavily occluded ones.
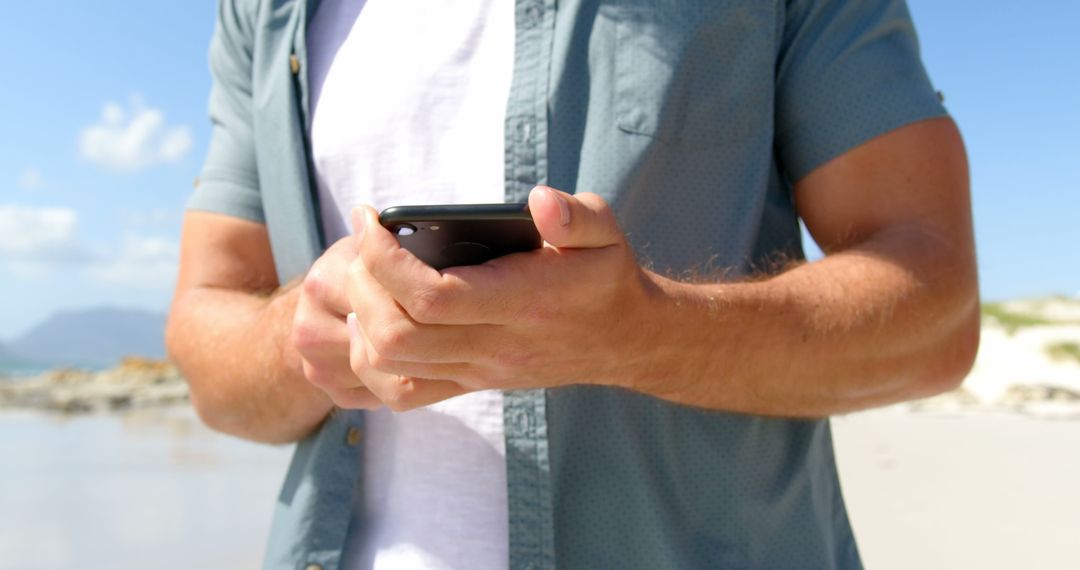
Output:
[289,236,382,409]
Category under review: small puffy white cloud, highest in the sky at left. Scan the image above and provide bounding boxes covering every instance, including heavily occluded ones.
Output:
[79,96,192,172]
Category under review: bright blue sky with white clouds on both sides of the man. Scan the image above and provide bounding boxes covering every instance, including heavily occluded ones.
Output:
[0,0,1080,340]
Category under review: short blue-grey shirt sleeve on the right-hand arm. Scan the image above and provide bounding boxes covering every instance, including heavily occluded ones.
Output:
[777,0,946,180]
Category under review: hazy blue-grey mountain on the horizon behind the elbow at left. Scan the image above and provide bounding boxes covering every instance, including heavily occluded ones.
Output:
[8,308,165,368]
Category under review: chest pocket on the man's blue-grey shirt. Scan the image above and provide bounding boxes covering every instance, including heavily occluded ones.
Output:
[615,0,779,146]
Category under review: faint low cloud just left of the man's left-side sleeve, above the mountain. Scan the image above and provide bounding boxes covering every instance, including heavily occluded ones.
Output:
[90,234,180,289]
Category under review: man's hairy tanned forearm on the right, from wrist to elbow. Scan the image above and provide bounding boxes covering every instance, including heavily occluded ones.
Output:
[632,227,978,417]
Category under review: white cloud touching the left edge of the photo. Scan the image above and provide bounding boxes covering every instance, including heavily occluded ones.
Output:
[0,204,90,261]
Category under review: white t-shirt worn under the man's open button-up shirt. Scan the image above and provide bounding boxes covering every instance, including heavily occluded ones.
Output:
[308,0,514,569]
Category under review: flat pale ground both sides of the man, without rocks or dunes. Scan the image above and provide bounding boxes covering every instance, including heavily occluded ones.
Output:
[0,408,1080,570]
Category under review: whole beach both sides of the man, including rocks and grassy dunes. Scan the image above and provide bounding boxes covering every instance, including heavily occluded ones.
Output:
[0,299,1080,570]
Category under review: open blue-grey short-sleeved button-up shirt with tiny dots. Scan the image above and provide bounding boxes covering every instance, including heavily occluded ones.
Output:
[189,0,944,570]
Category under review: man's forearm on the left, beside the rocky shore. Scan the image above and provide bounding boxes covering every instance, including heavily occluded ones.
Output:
[166,287,332,443]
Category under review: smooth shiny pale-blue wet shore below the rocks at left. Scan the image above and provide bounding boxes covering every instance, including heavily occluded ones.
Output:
[0,409,291,570]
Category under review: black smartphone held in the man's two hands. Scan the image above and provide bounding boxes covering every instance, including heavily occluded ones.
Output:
[379,203,543,269]
